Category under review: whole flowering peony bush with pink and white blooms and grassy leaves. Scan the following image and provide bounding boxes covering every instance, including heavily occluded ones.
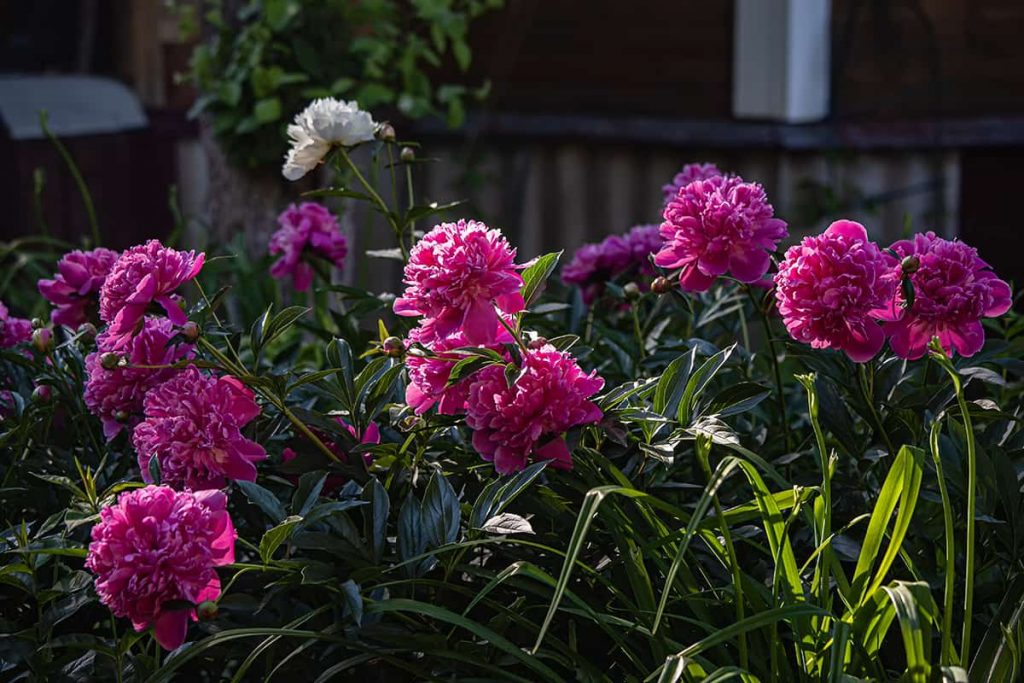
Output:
[0,100,1024,681]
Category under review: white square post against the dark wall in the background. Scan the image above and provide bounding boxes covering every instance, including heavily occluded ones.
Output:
[732,0,831,123]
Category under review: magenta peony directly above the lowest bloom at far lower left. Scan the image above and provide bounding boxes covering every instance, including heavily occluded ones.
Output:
[132,366,266,488]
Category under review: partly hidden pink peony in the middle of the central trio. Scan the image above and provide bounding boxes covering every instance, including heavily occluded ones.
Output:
[406,321,514,415]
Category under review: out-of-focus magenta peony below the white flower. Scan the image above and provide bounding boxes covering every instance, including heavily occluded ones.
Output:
[269,202,348,292]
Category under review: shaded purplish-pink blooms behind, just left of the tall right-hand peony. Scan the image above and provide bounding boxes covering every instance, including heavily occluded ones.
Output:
[562,225,662,304]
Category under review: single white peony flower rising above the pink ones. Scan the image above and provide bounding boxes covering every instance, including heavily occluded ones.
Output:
[282,97,377,180]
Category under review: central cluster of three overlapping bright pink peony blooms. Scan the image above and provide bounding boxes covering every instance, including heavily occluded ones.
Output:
[394,220,602,473]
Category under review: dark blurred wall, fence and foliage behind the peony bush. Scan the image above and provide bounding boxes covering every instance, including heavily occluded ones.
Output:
[0,0,1024,283]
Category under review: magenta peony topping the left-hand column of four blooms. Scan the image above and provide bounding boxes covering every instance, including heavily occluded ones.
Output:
[99,240,206,344]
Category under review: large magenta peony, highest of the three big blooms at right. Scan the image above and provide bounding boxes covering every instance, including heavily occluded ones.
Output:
[654,176,787,292]
